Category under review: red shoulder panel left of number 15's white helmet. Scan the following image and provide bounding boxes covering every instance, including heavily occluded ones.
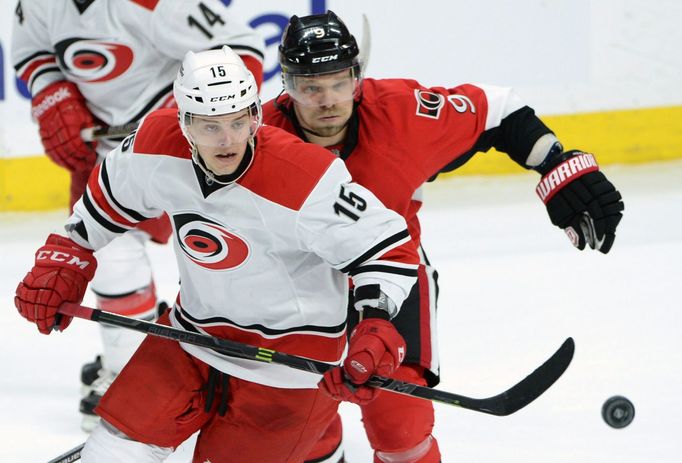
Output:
[133,108,192,159]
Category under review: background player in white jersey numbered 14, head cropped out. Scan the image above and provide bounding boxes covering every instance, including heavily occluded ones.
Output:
[12,0,263,430]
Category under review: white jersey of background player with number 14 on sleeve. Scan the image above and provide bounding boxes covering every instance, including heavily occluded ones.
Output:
[12,0,264,147]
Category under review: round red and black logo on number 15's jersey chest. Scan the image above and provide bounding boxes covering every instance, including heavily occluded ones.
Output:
[173,214,249,270]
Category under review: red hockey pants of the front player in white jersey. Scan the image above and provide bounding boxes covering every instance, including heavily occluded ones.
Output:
[97,315,338,463]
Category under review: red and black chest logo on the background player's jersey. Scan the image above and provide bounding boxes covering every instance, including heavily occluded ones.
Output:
[55,38,133,83]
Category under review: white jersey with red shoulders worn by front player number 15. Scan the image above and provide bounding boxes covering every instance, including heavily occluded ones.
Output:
[67,109,418,388]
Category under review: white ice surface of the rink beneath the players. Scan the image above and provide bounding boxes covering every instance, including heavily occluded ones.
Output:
[0,162,682,463]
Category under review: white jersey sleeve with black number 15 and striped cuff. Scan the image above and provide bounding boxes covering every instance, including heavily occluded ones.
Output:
[298,159,418,307]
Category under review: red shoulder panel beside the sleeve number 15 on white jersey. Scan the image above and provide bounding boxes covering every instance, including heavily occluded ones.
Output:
[237,126,336,211]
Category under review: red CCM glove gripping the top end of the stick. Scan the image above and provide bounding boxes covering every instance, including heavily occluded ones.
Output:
[14,234,97,334]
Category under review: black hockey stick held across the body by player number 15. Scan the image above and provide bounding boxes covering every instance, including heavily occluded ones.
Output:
[59,302,575,416]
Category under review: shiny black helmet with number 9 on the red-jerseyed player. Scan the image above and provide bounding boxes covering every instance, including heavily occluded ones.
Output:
[279,10,360,76]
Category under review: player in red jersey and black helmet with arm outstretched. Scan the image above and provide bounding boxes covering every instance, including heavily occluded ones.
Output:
[263,12,623,463]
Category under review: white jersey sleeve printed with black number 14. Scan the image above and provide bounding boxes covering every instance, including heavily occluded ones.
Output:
[151,0,264,62]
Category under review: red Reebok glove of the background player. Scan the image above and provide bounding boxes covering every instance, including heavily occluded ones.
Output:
[31,81,97,171]
